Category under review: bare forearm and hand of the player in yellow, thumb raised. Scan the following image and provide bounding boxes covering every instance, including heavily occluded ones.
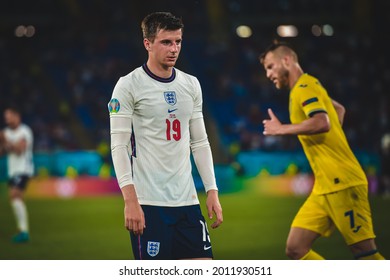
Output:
[263,109,330,135]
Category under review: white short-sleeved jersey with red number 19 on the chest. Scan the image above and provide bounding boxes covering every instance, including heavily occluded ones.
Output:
[109,65,203,206]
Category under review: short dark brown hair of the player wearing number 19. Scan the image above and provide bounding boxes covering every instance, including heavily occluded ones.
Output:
[141,12,184,42]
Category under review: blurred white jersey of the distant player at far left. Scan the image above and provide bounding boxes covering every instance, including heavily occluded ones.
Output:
[4,124,34,178]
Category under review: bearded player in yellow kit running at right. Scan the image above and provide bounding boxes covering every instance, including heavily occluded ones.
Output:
[260,43,384,260]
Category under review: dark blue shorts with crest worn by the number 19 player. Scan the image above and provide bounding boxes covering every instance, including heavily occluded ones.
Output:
[130,205,213,260]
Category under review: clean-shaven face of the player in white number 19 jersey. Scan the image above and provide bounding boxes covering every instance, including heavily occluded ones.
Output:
[145,29,182,68]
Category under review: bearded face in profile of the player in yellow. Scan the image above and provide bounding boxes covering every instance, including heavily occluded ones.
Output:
[263,52,289,89]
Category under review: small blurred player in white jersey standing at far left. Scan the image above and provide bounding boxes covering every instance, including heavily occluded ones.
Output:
[0,107,34,243]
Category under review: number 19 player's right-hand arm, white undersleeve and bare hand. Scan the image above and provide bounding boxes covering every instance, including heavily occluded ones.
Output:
[190,118,223,228]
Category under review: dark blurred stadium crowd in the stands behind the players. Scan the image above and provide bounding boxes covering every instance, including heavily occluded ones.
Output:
[0,0,390,160]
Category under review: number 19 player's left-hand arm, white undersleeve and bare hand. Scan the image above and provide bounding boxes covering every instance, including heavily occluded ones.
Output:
[110,116,145,234]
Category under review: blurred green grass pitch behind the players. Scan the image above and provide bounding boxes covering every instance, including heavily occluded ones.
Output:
[0,186,390,260]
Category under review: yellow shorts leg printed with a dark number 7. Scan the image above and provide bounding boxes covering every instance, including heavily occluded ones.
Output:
[328,186,375,245]
